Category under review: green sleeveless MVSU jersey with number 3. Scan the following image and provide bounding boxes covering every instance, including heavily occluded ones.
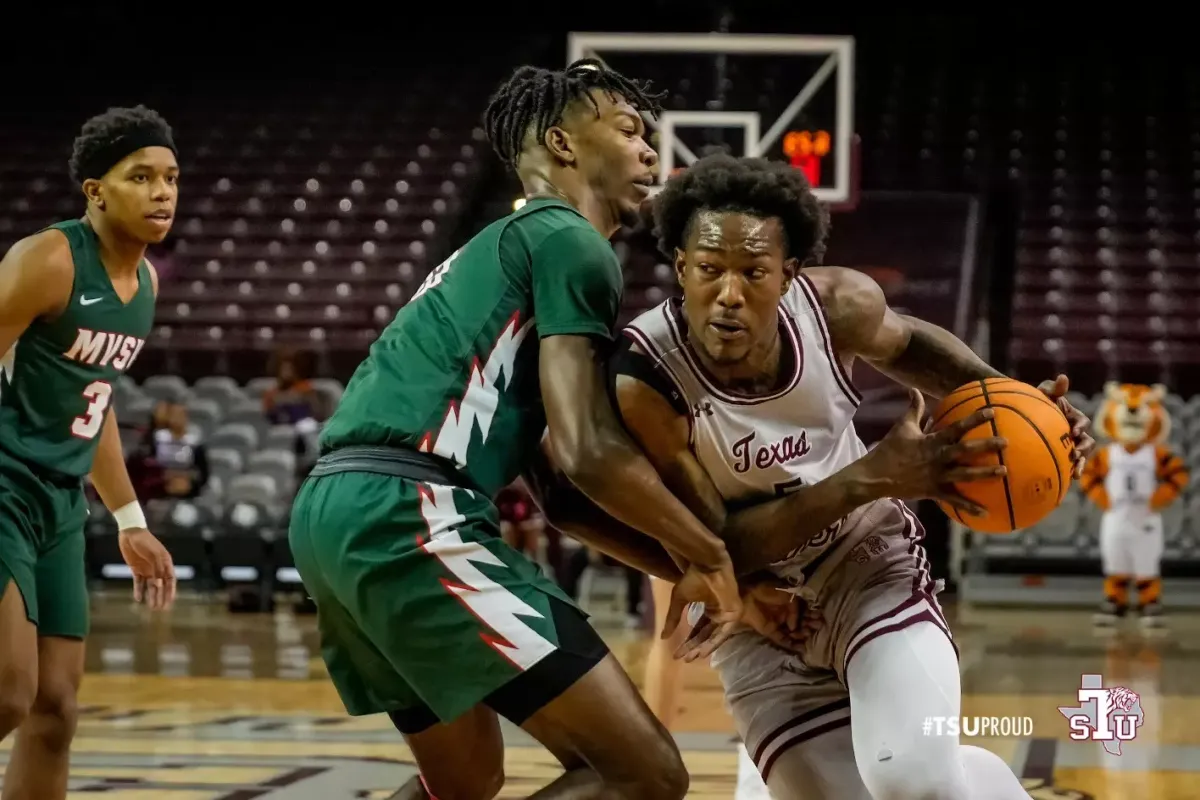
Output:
[0,219,155,477]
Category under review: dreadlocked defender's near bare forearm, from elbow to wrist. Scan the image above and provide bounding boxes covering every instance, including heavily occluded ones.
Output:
[558,431,728,571]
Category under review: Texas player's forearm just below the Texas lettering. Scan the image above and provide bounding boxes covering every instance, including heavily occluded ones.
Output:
[721,462,883,578]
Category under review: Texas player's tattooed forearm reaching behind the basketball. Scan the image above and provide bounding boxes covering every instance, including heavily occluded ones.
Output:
[871,317,1004,399]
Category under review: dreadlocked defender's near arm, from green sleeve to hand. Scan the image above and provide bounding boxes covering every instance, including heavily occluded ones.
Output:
[528,219,742,639]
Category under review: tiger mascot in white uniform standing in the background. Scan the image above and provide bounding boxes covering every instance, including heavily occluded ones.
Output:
[1080,383,1188,627]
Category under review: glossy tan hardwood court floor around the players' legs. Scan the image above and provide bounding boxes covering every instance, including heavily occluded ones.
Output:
[0,599,1200,800]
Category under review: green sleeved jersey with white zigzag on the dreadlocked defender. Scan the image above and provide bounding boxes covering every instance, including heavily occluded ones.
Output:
[322,199,622,494]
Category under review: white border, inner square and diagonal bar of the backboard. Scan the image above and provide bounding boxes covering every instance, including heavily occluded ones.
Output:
[568,32,854,203]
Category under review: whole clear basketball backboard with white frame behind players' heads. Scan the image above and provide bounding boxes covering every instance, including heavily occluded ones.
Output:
[568,32,857,206]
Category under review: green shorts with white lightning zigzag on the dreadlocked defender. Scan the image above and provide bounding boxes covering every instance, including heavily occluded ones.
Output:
[289,455,608,733]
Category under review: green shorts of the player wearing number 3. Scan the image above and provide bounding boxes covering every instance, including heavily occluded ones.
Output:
[0,450,89,639]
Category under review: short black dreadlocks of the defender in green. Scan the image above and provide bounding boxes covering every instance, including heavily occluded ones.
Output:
[484,59,666,169]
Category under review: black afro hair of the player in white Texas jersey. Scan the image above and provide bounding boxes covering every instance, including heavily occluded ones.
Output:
[654,154,829,265]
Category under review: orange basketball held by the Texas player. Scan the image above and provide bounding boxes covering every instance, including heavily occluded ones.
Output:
[932,378,1073,534]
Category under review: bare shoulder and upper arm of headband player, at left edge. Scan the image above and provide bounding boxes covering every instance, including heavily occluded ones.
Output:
[0,230,74,356]
